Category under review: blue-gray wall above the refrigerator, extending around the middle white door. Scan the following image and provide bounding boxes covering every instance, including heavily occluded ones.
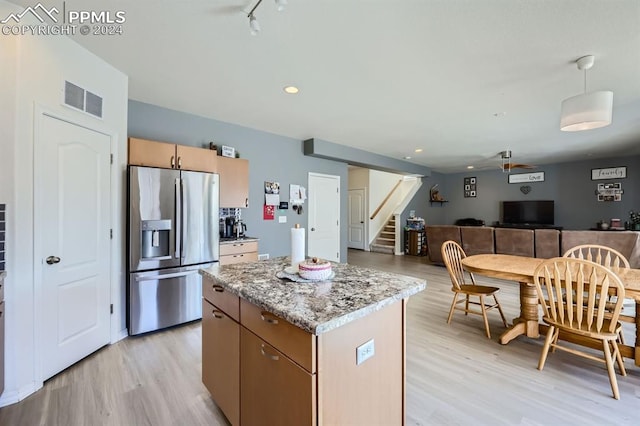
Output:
[128,101,348,262]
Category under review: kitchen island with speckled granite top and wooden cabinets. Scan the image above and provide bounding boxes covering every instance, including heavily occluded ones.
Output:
[200,257,426,426]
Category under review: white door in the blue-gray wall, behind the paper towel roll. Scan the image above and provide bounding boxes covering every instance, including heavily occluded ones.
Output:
[307,173,340,262]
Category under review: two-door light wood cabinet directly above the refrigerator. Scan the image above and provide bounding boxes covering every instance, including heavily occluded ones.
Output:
[129,138,218,173]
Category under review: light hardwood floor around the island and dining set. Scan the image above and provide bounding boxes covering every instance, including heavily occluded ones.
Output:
[0,250,640,426]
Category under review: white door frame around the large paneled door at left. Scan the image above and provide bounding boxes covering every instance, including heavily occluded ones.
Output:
[33,103,116,382]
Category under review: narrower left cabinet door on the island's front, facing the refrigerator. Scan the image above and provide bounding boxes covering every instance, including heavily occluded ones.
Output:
[202,299,240,425]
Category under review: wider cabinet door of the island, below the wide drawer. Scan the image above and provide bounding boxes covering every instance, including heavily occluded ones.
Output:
[240,327,316,426]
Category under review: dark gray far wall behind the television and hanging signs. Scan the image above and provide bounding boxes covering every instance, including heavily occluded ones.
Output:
[426,156,640,229]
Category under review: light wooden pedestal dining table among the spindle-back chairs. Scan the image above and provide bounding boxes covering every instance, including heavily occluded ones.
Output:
[462,254,640,366]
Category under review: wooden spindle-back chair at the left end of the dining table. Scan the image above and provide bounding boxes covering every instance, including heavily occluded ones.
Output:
[440,240,507,338]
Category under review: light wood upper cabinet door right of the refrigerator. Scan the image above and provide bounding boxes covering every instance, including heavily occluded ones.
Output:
[218,157,249,208]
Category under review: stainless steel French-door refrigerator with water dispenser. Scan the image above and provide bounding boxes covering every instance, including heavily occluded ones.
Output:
[127,166,220,335]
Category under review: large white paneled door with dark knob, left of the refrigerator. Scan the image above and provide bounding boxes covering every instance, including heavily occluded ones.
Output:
[35,114,111,380]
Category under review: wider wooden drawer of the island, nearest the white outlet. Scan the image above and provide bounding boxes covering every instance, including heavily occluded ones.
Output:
[240,299,317,374]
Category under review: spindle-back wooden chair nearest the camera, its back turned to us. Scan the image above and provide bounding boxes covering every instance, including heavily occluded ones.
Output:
[533,257,626,399]
